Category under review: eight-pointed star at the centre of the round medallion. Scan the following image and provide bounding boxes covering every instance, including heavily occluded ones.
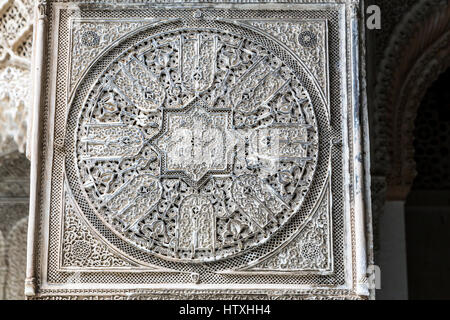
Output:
[155,99,237,185]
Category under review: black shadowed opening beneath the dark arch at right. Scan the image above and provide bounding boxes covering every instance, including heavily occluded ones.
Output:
[405,69,450,300]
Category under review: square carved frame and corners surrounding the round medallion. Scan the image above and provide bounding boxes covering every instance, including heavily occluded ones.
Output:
[26,0,371,299]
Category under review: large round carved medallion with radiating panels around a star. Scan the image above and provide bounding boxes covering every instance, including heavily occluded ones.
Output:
[76,29,319,262]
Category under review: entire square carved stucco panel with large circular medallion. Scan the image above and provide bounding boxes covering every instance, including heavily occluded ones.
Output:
[27,2,368,298]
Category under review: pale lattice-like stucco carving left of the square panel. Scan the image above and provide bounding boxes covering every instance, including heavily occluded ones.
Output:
[0,0,33,153]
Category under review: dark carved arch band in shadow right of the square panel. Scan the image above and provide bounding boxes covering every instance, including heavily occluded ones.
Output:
[372,0,450,200]
